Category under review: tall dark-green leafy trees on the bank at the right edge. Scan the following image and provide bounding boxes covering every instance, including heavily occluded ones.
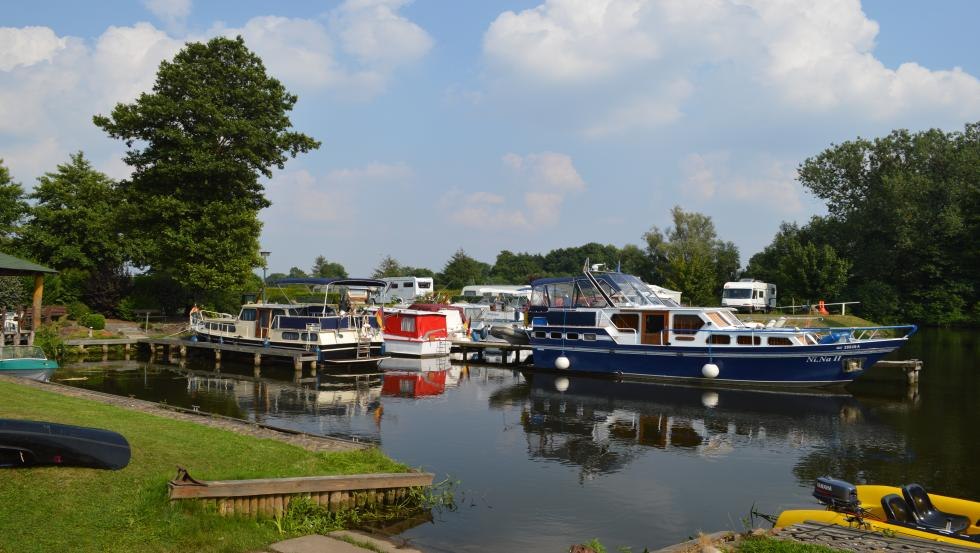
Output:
[799,123,980,323]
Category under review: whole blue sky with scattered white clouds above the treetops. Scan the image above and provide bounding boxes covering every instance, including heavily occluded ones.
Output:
[0,0,980,274]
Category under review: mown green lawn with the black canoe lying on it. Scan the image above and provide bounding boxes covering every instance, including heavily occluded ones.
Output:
[0,381,406,553]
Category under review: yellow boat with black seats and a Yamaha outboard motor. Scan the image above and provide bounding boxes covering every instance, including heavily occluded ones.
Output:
[775,477,980,549]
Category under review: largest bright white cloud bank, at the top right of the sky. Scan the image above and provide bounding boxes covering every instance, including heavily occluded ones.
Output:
[483,0,980,133]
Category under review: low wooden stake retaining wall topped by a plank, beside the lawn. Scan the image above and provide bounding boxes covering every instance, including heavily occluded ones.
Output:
[168,469,433,518]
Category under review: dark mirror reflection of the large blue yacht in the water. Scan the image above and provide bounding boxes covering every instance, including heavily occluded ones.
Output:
[490,372,866,474]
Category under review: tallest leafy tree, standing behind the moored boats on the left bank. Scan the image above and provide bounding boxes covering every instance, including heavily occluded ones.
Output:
[94,37,319,295]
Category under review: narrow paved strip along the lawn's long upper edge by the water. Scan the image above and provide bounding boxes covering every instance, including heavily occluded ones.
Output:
[0,375,367,452]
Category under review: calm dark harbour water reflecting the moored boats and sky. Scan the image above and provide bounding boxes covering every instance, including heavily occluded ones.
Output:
[54,329,980,551]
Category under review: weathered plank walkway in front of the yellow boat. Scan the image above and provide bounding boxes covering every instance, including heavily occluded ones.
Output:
[774,520,977,553]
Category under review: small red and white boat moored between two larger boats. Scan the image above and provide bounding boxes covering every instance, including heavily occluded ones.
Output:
[379,309,452,357]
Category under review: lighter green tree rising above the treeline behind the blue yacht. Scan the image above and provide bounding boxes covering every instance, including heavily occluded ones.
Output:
[643,206,740,305]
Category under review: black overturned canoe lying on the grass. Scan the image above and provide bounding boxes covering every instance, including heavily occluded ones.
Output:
[0,419,131,470]
